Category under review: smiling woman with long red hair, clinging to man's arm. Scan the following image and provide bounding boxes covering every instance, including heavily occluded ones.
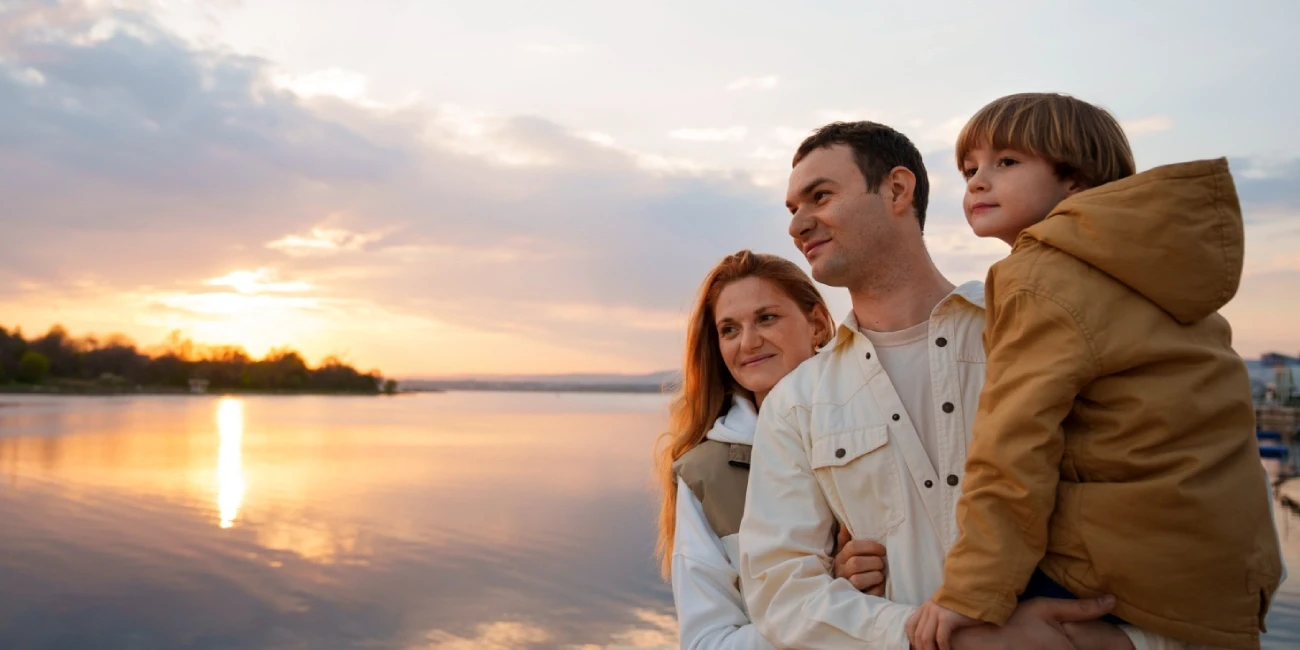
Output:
[655,251,884,650]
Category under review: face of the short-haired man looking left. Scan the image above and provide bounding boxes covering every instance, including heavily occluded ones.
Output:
[785,144,892,286]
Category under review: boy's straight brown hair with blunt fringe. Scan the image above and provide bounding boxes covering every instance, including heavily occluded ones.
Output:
[957,92,1136,187]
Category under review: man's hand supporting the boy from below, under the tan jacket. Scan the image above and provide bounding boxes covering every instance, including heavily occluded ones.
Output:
[953,595,1132,650]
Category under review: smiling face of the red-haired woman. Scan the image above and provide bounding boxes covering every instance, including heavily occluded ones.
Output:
[714,277,829,404]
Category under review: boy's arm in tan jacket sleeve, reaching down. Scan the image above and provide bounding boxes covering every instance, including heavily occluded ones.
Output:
[935,289,1099,625]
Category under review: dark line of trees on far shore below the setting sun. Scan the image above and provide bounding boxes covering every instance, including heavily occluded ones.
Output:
[0,325,397,393]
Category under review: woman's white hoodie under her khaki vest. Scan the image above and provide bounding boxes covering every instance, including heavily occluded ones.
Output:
[672,395,774,650]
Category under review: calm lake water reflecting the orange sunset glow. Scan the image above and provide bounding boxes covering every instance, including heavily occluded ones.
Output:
[0,393,1300,650]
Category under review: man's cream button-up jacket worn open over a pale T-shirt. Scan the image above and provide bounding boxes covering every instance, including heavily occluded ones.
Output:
[740,282,984,650]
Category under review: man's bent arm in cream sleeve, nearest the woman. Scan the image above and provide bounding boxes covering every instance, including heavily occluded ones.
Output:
[740,397,914,650]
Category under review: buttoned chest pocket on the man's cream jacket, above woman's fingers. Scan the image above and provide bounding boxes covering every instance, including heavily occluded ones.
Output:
[809,425,904,541]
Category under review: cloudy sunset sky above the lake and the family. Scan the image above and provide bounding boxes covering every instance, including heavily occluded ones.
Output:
[0,0,1300,377]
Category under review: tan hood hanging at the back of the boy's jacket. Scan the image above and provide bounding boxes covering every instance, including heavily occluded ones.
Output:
[1018,159,1245,324]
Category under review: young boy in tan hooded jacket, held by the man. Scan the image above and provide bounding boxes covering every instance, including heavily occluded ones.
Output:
[907,94,1282,650]
